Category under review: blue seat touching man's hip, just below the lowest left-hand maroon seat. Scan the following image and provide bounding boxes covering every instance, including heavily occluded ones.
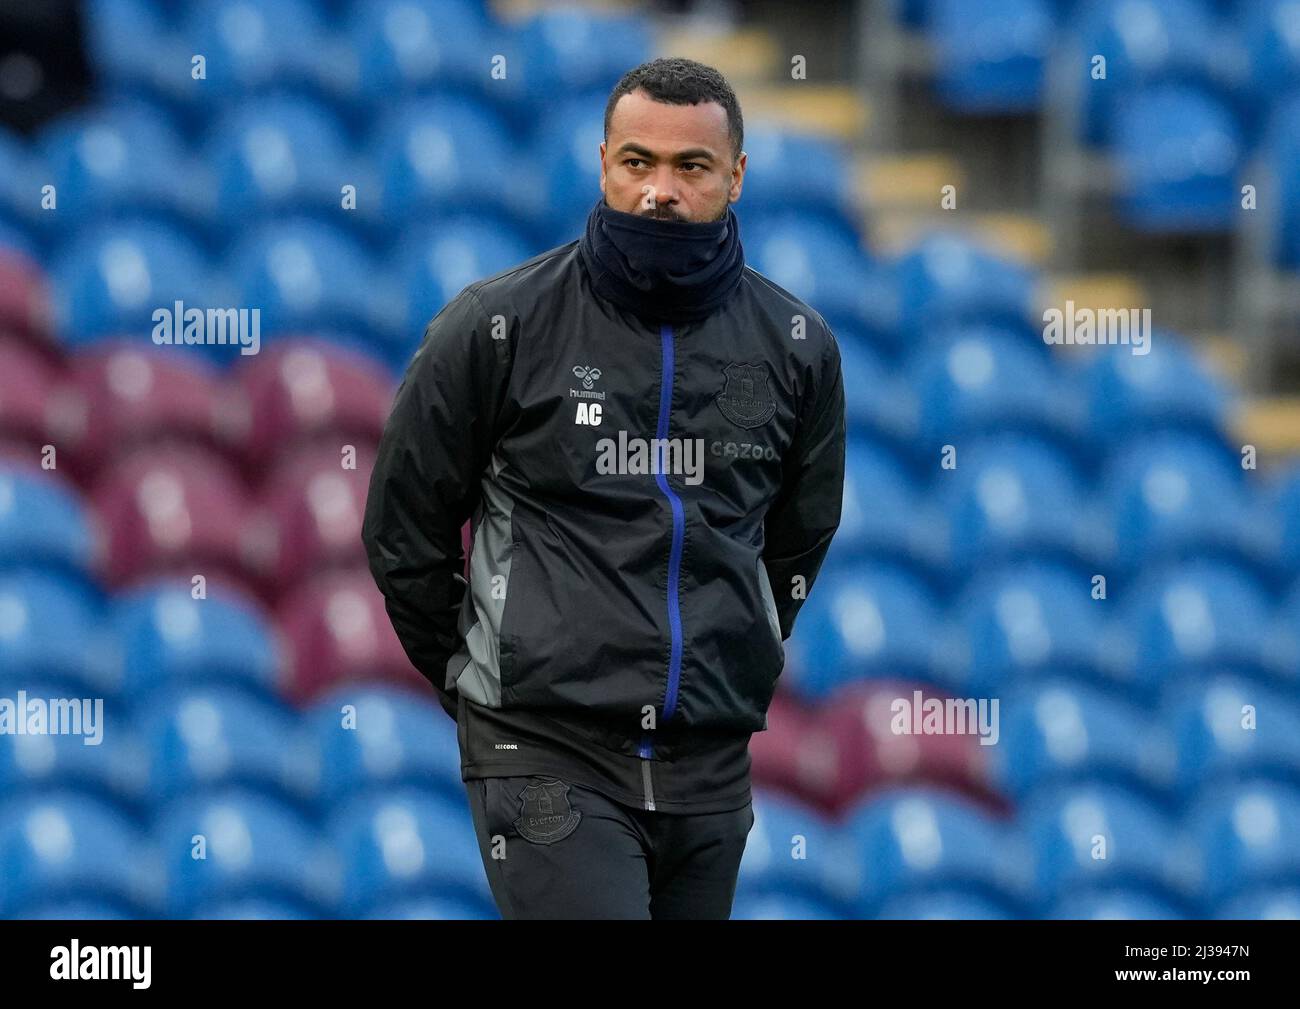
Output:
[307,684,465,807]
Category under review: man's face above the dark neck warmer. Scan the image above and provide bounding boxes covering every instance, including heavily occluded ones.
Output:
[601,88,746,221]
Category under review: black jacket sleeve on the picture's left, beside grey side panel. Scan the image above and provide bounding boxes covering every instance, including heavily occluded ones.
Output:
[361,289,510,718]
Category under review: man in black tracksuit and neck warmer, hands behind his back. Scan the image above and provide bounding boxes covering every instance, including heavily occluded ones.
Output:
[363,59,845,918]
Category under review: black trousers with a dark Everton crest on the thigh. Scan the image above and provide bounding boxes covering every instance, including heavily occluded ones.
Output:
[464,775,754,919]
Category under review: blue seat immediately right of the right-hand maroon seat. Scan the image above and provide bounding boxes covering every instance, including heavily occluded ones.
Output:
[991,677,1175,807]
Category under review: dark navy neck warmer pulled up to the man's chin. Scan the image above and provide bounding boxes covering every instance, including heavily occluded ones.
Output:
[579,196,745,322]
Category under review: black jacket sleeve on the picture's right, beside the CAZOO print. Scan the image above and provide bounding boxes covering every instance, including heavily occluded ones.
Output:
[763,329,846,641]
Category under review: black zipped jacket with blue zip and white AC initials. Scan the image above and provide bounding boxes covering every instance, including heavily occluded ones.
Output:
[363,218,845,809]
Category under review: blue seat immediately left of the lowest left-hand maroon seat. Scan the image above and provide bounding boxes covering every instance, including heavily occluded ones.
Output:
[109,584,280,701]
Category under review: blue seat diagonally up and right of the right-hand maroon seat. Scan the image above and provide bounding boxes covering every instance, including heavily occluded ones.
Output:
[953,560,1109,696]
